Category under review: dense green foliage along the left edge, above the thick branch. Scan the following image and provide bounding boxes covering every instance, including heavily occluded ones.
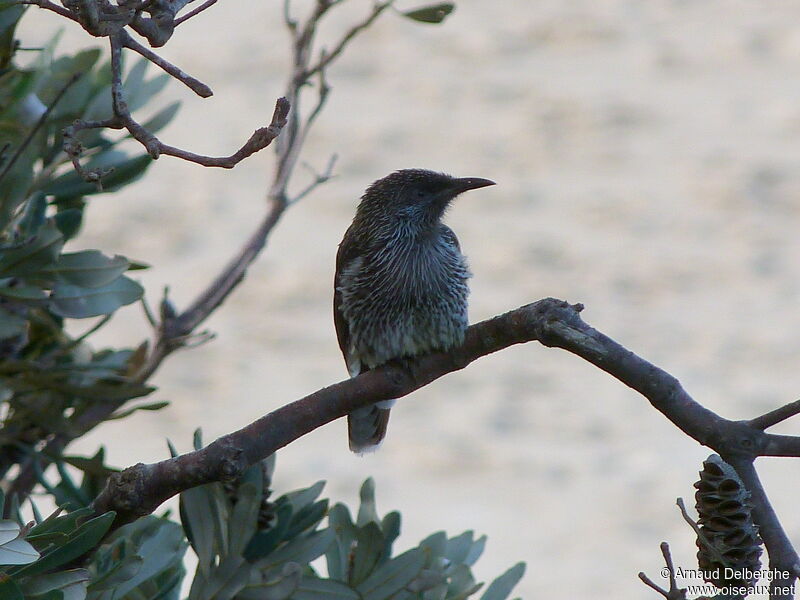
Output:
[0,1,177,494]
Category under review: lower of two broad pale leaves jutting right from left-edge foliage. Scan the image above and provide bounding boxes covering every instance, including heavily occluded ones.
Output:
[50,275,144,319]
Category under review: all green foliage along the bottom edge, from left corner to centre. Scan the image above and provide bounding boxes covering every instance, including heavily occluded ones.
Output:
[0,446,525,600]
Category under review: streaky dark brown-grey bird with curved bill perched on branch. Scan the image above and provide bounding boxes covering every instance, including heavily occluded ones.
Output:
[333,169,495,454]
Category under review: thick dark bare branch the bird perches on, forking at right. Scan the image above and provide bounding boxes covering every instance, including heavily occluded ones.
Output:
[94,298,800,597]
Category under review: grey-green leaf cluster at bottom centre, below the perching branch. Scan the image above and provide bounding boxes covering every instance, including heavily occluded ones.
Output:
[180,436,525,600]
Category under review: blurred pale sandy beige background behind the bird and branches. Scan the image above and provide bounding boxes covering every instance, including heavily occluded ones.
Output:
[18,0,800,600]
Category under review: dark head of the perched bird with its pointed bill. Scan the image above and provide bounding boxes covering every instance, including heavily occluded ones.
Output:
[358,169,494,230]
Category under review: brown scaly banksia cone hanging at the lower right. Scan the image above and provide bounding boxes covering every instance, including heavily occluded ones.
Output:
[694,454,761,588]
